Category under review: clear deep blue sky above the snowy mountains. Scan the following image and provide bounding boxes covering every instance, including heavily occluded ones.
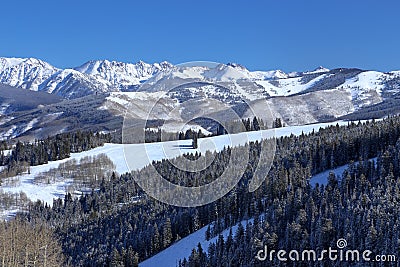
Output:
[0,0,400,71]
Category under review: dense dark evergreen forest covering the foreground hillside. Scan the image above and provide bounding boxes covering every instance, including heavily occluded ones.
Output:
[11,117,400,266]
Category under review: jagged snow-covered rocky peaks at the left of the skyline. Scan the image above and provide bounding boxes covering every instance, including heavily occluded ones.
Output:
[0,57,172,99]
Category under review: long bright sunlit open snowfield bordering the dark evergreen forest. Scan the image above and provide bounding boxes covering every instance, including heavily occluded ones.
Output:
[0,121,356,209]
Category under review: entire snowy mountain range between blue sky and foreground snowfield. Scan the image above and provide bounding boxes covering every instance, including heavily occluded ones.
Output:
[0,58,400,139]
